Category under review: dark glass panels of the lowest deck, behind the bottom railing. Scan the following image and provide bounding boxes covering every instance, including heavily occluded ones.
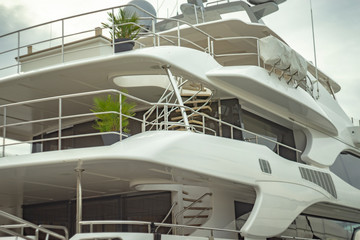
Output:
[23,192,171,236]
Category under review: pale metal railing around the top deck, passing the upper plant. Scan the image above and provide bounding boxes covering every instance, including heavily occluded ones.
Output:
[0,4,258,77]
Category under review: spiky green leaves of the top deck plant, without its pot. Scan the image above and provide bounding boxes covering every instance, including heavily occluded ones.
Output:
[101,9,140,39]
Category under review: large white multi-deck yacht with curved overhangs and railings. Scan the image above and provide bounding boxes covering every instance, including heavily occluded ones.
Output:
[0,0,360,240]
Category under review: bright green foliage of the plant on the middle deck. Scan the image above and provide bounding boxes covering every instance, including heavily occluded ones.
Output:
[90,95,136,133]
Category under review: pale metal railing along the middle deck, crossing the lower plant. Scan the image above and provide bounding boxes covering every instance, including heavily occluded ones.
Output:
[0,89,301,159]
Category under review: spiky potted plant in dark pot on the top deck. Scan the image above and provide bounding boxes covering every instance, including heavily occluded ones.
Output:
[101,9,140,52]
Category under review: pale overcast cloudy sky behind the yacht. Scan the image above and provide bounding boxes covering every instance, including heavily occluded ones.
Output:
[0,0,360,122]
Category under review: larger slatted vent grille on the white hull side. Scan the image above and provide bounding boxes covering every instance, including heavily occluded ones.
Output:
[299,167,337,198]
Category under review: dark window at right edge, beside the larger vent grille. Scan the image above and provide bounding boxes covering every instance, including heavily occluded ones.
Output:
[330,152,360,189]
